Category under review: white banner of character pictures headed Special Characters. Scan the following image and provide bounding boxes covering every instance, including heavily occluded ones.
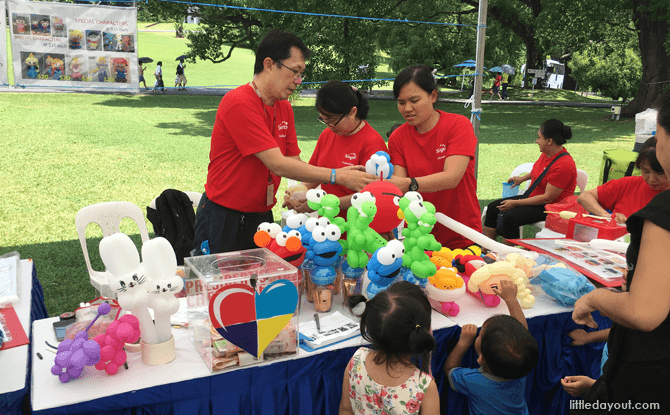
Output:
[8,0,139,89]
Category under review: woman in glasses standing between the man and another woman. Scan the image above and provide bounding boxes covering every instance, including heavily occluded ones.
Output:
[288,81,388,216]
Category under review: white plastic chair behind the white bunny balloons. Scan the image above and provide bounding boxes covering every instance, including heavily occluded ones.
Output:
[74,202,149,298]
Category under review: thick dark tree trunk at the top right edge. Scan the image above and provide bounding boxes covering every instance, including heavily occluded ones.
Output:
[621,0,670,117]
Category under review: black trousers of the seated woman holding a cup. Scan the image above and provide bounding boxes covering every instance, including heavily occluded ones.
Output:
[484,196,547,239]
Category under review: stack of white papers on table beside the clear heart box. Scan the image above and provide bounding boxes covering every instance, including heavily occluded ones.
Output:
[300,311,360,349]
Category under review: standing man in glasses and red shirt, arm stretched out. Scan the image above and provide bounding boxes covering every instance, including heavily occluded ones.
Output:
[194,29,376,255]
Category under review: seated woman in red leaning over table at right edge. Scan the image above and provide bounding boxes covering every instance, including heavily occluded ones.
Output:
[577,137,670,223]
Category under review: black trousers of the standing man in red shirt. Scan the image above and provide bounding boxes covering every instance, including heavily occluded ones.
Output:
[193,193,274,255]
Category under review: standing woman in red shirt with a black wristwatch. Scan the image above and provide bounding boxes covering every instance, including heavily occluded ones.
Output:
[389,65,482,249]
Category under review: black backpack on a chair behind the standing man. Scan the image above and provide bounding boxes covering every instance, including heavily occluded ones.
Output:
[147,189,195,265]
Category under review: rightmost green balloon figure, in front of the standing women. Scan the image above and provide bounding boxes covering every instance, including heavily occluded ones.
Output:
[398,192,442,278]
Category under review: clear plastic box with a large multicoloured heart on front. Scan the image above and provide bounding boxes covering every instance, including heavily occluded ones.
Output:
[184,248,300,372]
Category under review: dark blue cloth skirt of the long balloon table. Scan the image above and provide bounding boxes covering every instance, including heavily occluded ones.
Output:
[36,313,610,415]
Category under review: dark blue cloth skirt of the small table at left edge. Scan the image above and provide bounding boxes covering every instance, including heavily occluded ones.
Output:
[0,262,49,415]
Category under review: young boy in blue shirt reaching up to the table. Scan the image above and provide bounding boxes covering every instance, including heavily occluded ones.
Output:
[444,280,540,415]
